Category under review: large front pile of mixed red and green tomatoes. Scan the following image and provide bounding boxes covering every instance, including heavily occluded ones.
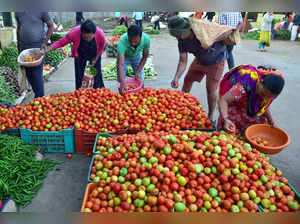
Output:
[83,130,299,212]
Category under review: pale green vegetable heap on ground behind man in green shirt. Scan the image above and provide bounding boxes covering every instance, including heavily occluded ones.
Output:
[102,61,157,80]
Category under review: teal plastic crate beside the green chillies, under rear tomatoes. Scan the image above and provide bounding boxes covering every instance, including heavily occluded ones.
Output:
[20,127,75,153]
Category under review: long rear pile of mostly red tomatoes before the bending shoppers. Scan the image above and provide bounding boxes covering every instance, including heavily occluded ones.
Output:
[0,88,212,133]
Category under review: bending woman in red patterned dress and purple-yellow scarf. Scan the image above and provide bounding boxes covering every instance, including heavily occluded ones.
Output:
[218,65,284,133]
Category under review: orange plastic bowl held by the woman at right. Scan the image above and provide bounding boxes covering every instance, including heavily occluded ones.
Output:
[245,124,290,154]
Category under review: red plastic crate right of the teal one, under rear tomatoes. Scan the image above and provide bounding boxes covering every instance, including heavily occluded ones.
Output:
[75,129,127,154]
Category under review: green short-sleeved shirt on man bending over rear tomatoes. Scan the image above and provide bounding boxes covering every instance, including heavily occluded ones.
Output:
[118,33,150,58]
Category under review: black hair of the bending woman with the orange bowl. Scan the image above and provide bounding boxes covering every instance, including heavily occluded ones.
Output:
[262,74,284,95]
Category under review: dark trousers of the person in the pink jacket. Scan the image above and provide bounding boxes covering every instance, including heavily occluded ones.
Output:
[74,56,104,89]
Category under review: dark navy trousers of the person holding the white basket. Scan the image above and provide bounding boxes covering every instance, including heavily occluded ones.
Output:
[25,63,45,98]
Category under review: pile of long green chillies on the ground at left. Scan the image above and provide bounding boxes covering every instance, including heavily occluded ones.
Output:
[0,134,57,207]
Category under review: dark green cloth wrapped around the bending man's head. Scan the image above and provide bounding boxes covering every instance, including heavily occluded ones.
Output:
[168,16,191,37]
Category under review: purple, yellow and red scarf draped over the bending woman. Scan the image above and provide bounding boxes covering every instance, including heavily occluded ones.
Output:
[220,65,283,117]
